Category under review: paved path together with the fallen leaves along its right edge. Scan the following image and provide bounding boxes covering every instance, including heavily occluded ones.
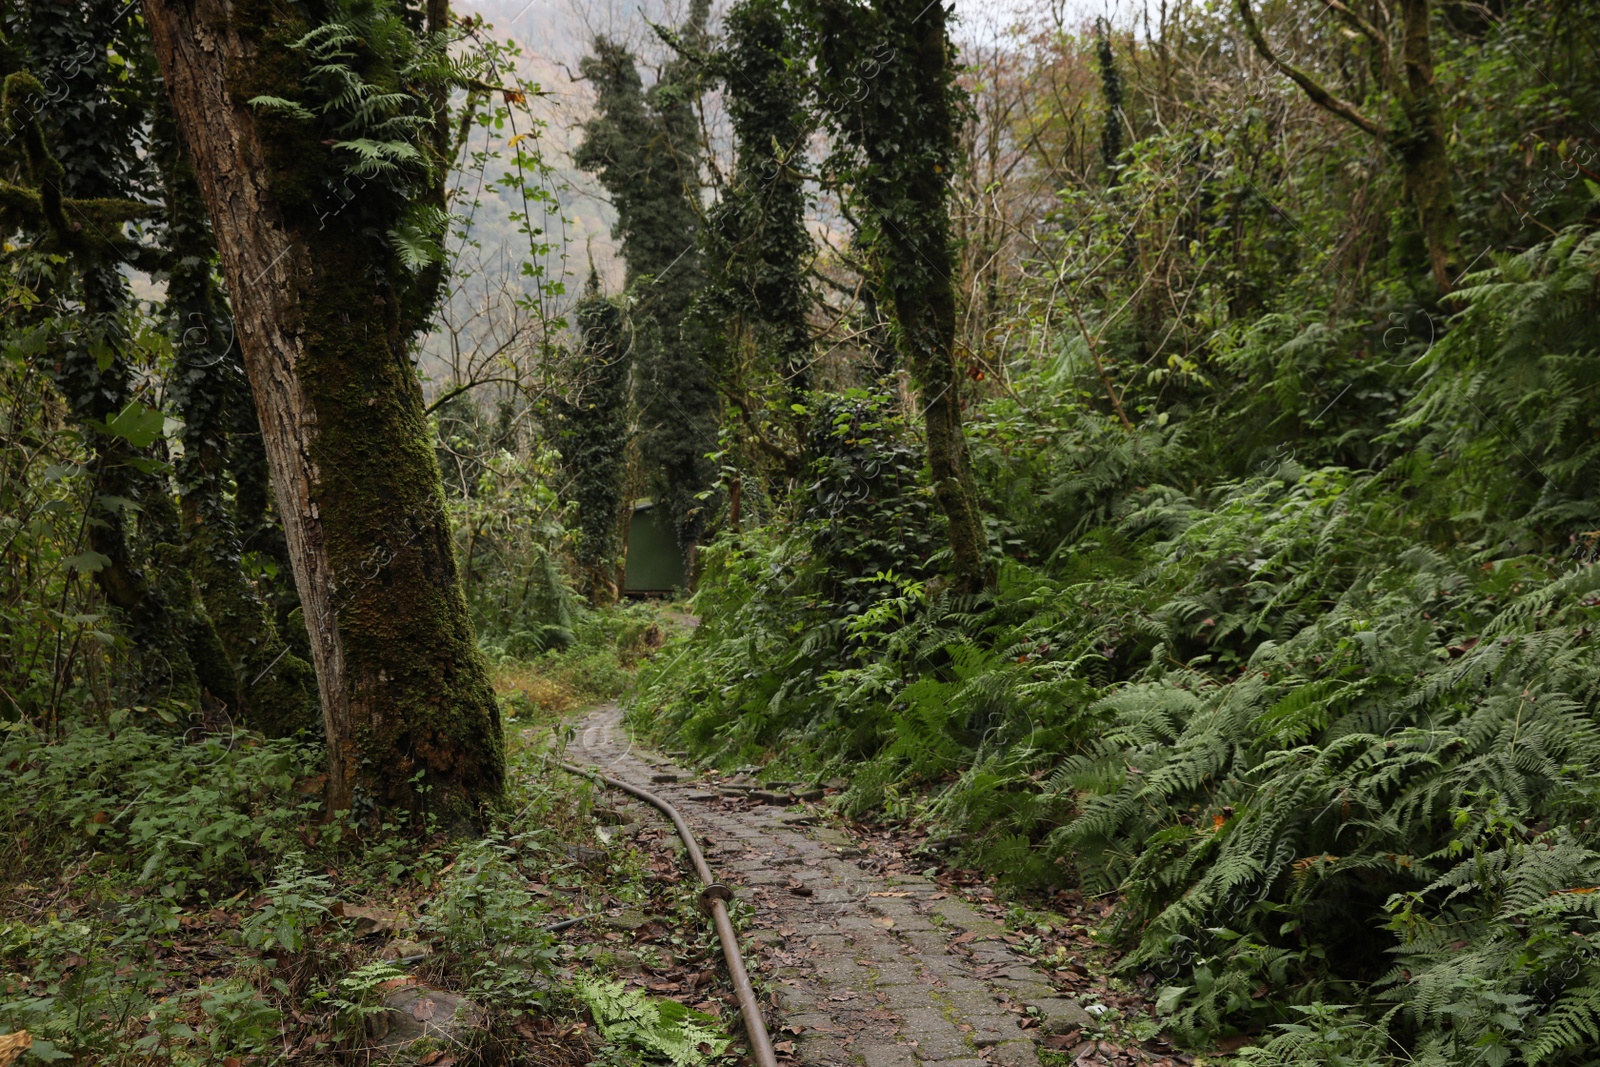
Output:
[566,705,1194,1067]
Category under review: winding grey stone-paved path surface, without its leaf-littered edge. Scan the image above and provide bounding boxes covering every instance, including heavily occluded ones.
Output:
[566,707,1094,1067]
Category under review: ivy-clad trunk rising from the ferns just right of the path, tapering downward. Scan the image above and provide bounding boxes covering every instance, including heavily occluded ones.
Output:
[819,0,992,592]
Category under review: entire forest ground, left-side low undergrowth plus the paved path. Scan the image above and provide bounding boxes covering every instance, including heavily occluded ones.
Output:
[0,611,1222,1067]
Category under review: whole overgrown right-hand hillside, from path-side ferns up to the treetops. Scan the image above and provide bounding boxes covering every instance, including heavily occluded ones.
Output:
[637,3,1600,1064]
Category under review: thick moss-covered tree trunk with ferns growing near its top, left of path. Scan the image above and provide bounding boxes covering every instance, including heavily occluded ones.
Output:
[146,0,504,821]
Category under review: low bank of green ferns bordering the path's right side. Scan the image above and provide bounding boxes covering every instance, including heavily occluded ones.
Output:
[634,223,1600,1065]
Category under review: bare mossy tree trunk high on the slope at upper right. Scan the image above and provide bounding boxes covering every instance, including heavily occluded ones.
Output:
[1390,0,1461,293]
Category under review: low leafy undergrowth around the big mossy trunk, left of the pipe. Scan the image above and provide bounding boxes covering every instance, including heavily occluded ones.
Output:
[0,608,728,1067]
